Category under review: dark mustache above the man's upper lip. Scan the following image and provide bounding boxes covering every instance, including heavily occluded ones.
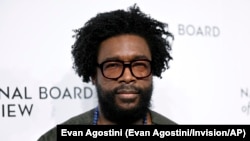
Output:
[114,85,141,94]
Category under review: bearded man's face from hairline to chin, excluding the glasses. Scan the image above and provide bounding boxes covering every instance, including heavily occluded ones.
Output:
[94,34,153,123]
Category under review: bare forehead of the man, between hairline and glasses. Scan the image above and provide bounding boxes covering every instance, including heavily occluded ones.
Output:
[98,35,151,60]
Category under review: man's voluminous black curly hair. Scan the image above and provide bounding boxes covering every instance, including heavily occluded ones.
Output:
[71,4,174,82]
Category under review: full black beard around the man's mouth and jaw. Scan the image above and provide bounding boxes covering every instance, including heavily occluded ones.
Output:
[96,83,153,124]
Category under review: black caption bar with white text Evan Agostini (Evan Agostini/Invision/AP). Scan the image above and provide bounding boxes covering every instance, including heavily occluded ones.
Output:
[57,125,250,141]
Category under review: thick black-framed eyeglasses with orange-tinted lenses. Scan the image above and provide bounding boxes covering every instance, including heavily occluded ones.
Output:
[97,59,151,80]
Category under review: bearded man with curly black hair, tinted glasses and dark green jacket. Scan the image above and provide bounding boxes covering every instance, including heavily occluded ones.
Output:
[39,5,176,141]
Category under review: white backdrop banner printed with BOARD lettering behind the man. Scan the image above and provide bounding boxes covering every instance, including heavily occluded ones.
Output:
[0,0,250,141]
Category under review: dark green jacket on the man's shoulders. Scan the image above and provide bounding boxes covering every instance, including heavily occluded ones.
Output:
[38,109,177,141]
